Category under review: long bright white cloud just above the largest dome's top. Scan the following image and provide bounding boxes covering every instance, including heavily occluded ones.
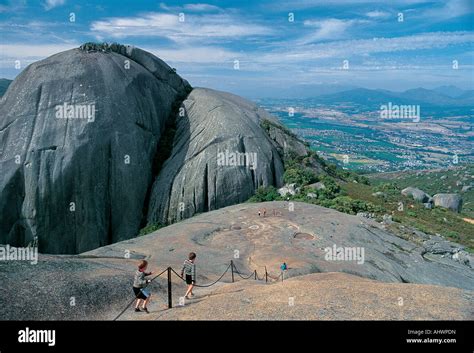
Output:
[91,12,273,43]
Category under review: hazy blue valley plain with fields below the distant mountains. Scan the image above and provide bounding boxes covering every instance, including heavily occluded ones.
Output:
[259,94,474,172]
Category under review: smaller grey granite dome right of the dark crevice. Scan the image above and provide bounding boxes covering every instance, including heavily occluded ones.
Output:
[148,88,306,224]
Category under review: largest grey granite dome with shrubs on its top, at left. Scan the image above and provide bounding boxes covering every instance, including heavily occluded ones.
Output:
[0,46,191,253]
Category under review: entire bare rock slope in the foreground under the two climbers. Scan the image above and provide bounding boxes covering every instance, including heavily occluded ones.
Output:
[0,202,474,320]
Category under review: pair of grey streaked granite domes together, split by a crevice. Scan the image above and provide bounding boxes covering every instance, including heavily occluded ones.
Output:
[0,43,307,254]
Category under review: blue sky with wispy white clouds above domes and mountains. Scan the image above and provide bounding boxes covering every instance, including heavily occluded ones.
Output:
[0,0,474,96]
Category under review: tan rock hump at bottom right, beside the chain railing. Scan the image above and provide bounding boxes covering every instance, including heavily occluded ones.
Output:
[151,272,474,320]
